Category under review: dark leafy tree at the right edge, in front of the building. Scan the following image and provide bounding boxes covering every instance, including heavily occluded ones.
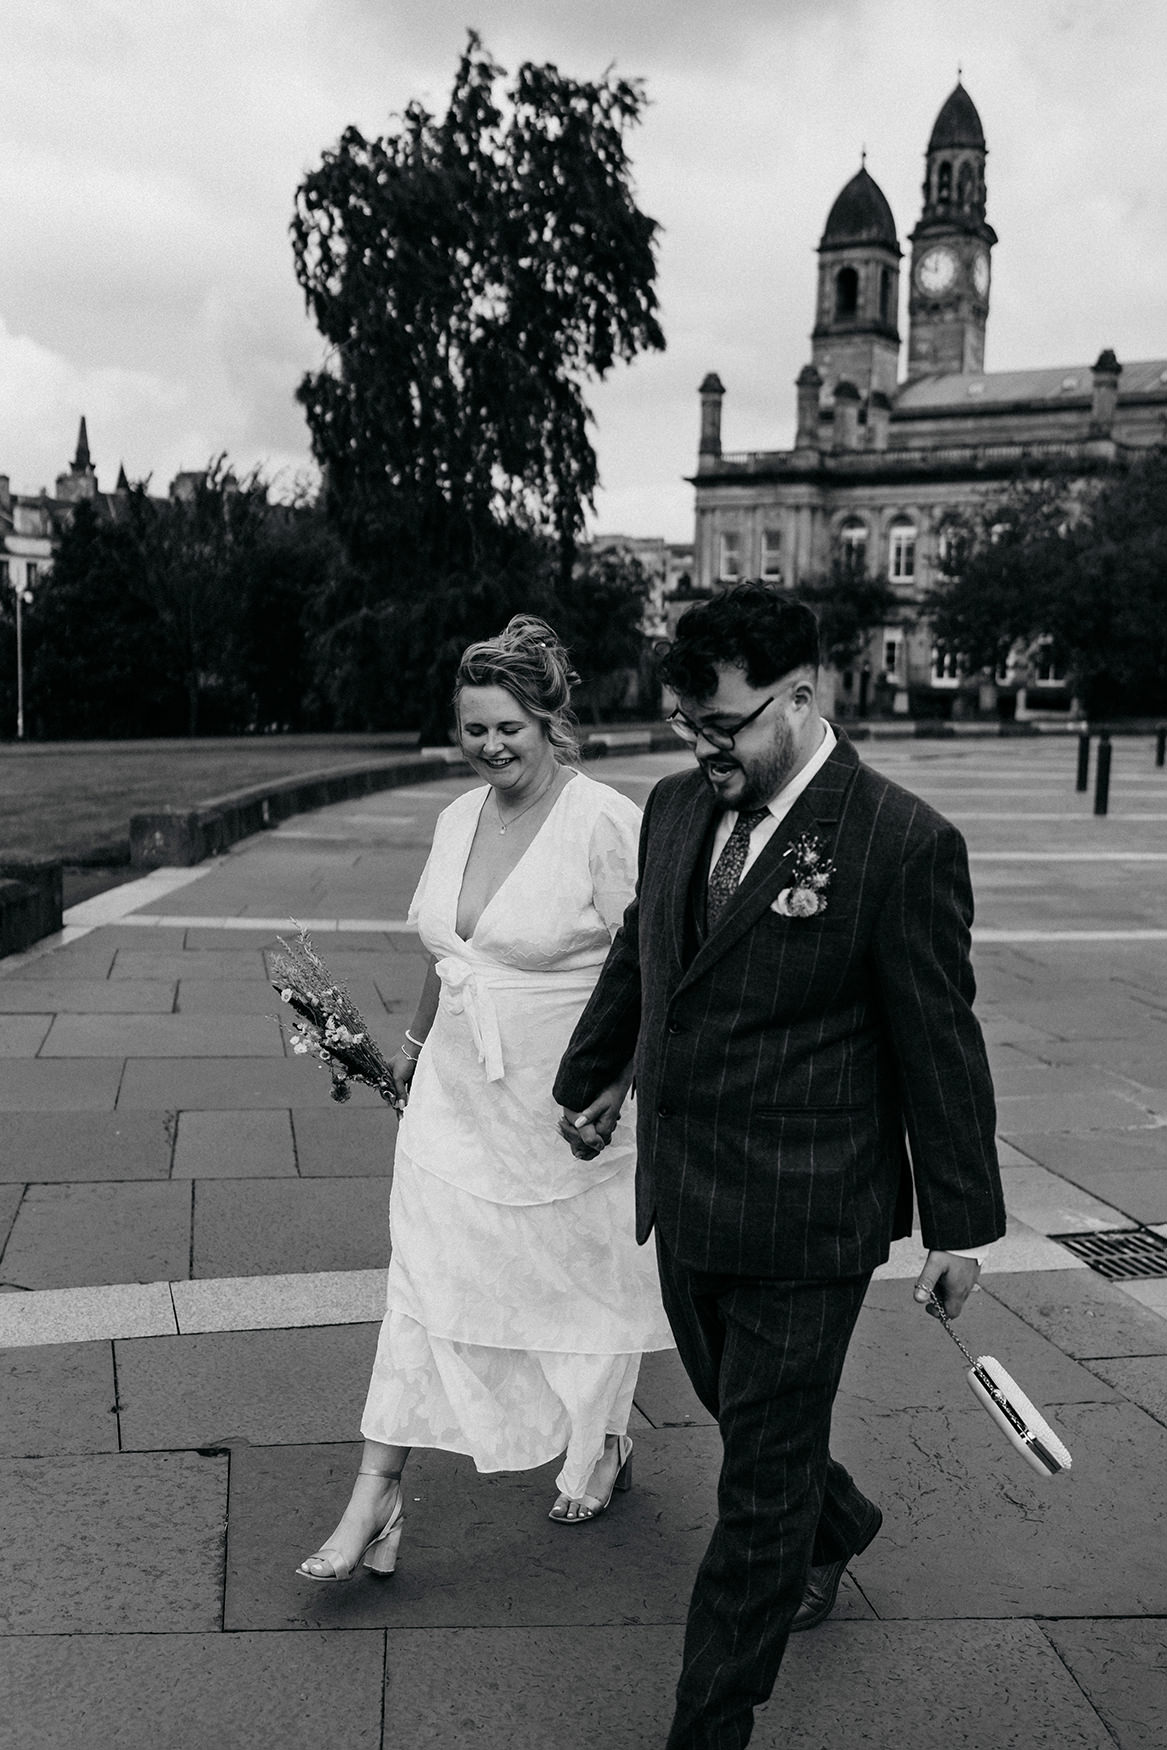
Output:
[931,462,1167,716]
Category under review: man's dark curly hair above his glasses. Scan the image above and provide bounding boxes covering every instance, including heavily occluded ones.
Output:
[658,583,819,700]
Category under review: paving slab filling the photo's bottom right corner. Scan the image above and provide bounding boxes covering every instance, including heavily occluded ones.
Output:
[1041,1617,1167,1750]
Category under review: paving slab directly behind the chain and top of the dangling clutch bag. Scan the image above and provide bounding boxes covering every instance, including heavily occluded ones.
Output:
[840,1283,1119,1411]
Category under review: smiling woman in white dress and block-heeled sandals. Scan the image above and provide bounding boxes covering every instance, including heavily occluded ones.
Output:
[297,614,672,1580]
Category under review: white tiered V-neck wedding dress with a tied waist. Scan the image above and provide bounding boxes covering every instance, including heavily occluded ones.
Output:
[360,772,672,1496]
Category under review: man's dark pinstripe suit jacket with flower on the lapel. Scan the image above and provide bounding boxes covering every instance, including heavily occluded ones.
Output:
[555,735,1004,1279]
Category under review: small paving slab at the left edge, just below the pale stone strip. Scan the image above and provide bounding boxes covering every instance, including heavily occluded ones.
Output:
[0,1342,117,1458]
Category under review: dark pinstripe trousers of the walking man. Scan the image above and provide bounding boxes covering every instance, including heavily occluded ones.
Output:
[656,1237,871,1750]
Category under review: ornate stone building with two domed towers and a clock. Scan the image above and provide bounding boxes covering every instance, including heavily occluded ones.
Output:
[691,82,1167,716]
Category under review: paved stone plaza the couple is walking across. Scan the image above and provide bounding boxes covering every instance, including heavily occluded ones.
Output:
[0,737,1167,1750]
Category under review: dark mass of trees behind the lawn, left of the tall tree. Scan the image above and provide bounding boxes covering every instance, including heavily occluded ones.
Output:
[24,472,336,737]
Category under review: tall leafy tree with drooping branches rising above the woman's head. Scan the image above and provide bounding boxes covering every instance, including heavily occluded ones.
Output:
[292,35,663,721]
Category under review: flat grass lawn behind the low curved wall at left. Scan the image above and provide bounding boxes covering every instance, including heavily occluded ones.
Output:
[0,735,413,861]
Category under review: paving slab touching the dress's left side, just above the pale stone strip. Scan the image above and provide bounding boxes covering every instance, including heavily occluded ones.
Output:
[194,1178,388,1276]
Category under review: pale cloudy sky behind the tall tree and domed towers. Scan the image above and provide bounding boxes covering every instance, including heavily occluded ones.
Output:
[0,0,1167,541]
